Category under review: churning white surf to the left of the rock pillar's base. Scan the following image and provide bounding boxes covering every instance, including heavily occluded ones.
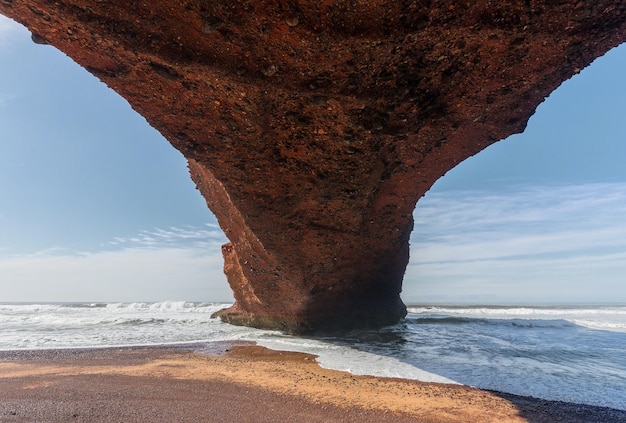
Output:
[0,302,232,350]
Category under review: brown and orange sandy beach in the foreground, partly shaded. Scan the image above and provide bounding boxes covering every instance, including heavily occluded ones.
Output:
[0,344,626,423]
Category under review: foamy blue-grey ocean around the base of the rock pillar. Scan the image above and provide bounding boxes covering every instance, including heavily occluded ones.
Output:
[0,302,626,410]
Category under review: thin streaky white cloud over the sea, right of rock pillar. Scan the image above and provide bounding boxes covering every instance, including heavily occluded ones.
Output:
[404,183,626,302]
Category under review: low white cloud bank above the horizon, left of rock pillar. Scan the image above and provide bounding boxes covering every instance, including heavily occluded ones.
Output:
[0,226,232,301]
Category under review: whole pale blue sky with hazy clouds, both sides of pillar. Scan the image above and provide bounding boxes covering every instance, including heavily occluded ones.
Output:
[0,17,626,303]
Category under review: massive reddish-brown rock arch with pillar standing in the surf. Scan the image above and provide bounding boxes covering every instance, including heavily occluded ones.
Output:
[0,0,626,333]
